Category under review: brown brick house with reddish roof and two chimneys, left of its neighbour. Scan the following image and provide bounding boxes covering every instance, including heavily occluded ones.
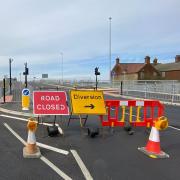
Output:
[111,56,161,80]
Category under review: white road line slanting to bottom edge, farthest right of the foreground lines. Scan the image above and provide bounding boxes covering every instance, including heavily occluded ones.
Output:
[70,149,93,180]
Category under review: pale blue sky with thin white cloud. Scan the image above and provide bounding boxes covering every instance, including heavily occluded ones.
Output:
[0,0,180,79]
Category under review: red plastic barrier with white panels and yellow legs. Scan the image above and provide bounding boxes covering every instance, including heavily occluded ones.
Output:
[100,100,164,127]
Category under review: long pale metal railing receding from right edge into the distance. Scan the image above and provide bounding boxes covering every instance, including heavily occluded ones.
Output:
[27,79,180,103]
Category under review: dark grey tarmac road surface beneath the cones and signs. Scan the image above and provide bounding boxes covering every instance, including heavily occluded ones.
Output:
[0,87,180,180]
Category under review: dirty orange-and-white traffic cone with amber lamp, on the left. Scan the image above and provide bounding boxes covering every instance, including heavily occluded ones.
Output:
[23,118,41,158]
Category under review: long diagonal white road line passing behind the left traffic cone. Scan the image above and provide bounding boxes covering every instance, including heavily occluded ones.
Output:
[4,123,72,180]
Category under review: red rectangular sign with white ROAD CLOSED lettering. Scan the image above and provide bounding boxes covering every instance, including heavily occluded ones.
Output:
[33,91,69,115]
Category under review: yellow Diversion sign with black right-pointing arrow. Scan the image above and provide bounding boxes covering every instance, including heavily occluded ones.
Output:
[70,90,106,115]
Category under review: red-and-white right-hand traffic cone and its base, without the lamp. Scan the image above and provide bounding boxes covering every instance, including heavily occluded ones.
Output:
[138,126,169,158]
